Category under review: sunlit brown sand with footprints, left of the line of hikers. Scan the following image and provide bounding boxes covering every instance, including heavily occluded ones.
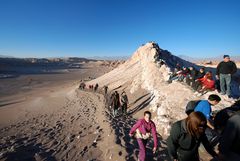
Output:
[0,61,125,160]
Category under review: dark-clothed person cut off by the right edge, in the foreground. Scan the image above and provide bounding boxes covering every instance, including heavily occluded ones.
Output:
[219,113,240,161]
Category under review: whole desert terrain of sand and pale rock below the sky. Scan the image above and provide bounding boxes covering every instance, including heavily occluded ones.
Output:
[0,42,240,161]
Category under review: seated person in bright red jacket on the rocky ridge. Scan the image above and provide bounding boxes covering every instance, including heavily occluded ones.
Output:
[193,72,215,93]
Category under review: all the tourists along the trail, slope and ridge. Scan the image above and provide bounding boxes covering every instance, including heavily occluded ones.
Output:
[79,55,240,161]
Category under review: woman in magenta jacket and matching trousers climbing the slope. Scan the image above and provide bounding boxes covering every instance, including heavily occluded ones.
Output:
[129,111,157,161]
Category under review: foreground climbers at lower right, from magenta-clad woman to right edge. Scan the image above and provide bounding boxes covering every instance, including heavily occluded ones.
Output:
[129,95,240,161]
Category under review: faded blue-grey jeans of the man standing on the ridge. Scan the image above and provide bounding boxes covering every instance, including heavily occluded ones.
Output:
[220,74,232,96]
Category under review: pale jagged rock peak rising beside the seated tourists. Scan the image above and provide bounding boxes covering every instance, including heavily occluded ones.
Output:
[89,42,228,137]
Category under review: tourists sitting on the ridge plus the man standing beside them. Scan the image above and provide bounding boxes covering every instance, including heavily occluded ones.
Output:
[168,55,237,98]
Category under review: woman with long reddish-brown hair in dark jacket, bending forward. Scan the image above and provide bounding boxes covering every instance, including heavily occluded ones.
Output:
[167,112,217,161]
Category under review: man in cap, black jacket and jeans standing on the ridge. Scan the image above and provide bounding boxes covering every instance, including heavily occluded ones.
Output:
[216,55,237,97]
